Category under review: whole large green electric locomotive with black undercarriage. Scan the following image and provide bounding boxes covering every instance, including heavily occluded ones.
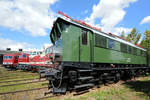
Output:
[46,17,149,94]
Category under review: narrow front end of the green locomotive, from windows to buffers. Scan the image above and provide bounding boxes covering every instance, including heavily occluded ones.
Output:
[45,17,67,93]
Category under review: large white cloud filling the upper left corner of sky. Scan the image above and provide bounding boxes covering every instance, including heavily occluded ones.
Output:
[0,0,58,36]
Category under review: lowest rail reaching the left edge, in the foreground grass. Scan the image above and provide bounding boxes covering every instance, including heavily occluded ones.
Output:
[0,87,48,95]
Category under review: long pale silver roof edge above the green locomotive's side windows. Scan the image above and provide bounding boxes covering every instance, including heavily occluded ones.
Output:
[57,17,146,51]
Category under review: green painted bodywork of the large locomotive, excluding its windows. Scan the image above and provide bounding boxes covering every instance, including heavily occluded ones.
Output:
[52,19,146,64]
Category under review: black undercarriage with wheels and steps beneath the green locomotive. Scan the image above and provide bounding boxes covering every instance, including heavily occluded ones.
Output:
[45,62,150,94]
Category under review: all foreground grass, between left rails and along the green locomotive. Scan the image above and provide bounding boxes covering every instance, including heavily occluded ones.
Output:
[0,68,150,100]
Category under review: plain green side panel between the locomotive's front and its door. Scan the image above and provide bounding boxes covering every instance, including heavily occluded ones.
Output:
[62,25,81,62]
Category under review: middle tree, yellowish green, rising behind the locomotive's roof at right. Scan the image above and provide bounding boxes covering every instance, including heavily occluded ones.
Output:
[126,28,141,44]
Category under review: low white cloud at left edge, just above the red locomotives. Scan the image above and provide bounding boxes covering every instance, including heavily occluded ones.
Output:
[0,37,31,51]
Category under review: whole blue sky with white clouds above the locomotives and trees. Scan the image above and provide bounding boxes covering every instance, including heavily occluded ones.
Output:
[0,0,150,50]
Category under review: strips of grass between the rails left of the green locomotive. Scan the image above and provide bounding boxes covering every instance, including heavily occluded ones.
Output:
[0,66,48,100]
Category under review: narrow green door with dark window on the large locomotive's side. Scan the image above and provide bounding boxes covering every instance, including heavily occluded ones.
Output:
[79,29,92,62]
